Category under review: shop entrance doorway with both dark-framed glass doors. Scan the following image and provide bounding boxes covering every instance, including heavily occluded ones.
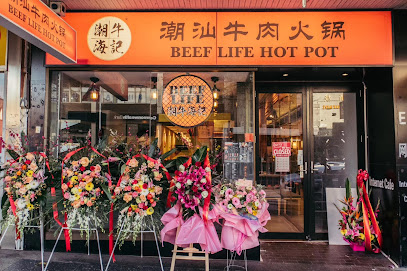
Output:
[256,84,364,239]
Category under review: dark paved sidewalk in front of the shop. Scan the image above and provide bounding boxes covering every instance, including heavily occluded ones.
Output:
[0,242,395,271]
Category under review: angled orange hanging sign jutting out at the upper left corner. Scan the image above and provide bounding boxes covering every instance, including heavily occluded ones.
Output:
[0,0,76,63]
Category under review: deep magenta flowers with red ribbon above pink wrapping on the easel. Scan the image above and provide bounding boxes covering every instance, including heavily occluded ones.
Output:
[170,147,214,219]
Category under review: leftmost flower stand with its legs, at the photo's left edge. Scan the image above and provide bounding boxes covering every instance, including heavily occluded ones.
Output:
[0,152,50,271]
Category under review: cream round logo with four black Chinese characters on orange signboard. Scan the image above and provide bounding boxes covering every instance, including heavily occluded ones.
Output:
[88,17,131,61]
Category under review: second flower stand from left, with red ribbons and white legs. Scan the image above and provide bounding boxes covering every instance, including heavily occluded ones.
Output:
[44,145,113,271]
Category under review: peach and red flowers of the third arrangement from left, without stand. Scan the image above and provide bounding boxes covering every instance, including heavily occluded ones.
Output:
[113,155,168,244]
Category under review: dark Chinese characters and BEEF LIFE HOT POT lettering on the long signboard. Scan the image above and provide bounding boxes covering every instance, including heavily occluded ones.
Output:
[171,20,345,58]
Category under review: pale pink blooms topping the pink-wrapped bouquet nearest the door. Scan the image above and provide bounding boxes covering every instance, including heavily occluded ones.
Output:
[215,183,266,219]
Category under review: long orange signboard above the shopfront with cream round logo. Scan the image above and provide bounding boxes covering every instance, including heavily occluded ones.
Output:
[47,11,393,66]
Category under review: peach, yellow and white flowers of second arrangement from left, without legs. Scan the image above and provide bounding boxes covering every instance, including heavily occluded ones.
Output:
[61,153,111,234]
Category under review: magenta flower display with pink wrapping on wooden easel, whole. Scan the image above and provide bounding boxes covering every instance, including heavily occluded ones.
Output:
[161,153,222,271]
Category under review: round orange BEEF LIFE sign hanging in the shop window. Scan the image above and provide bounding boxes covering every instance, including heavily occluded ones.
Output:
[163,75,213,127]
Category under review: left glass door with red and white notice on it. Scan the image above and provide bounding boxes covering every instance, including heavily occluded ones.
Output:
[257,91,307,234]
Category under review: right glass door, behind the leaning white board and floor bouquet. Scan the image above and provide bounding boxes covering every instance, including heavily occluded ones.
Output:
[310,87,363,236]
